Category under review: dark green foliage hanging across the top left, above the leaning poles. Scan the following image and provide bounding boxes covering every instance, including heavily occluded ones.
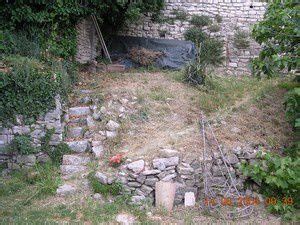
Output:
[0,0,164,59]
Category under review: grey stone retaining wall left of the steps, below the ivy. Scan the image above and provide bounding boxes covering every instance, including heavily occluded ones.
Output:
[0,96,64,169]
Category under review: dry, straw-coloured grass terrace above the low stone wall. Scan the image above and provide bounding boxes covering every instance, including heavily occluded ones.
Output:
[76,72,290,159]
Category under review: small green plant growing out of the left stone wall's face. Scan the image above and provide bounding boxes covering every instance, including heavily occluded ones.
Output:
[6,135,37,155]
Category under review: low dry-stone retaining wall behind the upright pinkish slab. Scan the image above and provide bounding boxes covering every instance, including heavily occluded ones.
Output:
[96,148,258,205]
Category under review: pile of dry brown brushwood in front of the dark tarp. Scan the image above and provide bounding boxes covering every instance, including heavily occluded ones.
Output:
[129,47,163,66]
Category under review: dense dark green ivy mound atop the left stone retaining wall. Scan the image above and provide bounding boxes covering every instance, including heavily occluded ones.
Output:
[0,57,62,125]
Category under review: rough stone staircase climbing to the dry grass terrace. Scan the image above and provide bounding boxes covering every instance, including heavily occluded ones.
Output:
[57,92,104,196]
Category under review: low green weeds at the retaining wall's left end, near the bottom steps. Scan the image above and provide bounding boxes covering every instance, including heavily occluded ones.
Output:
[88,173,122,197]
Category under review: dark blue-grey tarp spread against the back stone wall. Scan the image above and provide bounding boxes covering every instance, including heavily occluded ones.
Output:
[107,36,196,69]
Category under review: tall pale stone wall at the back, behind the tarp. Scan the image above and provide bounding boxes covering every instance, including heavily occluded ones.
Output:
[121,0,267,75]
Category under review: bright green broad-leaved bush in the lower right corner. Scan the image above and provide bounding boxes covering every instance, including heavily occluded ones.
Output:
[242,153,300,218]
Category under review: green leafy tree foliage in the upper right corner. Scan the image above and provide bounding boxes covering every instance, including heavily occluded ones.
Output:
[252,0,299,77]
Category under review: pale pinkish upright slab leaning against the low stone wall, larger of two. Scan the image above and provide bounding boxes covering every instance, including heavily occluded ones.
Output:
[155,181,176,212]
